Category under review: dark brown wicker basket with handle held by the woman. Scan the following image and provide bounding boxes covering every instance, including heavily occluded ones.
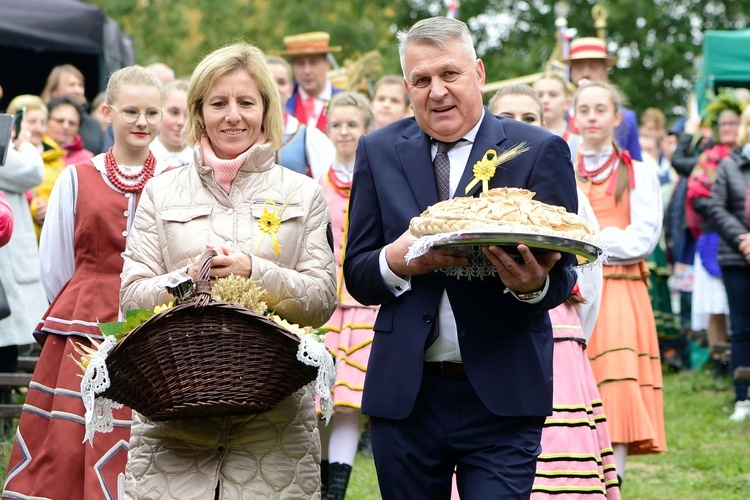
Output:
[102,249,317,421]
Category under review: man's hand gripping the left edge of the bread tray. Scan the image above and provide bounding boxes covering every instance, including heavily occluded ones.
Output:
[385,229,469,278]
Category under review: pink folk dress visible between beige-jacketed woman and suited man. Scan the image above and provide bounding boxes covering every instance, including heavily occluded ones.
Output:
[319,168,378,411]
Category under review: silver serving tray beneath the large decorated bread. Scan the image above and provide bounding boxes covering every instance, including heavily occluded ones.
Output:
[433,232,602,264]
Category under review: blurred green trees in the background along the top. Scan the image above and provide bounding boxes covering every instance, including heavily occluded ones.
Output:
[90,0,750,119]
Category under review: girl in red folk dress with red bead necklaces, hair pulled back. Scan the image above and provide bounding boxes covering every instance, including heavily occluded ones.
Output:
[3,66,163,500]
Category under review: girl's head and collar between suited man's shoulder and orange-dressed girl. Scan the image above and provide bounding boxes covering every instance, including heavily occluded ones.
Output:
[533,73,581,161]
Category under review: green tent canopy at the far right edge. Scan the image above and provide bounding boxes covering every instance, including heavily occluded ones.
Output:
[695,28,750,113]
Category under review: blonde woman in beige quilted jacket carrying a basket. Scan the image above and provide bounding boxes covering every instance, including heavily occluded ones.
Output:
[121,43,336,500]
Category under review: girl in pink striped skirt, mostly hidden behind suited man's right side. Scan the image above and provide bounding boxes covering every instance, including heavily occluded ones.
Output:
[490,85,620,500]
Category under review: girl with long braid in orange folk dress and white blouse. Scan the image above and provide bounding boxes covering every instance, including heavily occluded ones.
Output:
[573,82,667,484]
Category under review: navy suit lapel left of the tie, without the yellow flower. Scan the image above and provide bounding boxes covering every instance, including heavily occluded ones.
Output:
[395,127,438,210]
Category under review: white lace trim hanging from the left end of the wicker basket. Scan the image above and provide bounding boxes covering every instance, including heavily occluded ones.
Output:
[81,335,122,446]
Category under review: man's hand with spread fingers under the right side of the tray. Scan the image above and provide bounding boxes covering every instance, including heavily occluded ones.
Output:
[482,243,562,293]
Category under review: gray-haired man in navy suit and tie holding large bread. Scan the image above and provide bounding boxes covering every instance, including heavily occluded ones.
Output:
[344,18,577,500]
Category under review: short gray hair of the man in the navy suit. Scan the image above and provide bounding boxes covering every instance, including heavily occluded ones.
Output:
[396,17,477,77]
